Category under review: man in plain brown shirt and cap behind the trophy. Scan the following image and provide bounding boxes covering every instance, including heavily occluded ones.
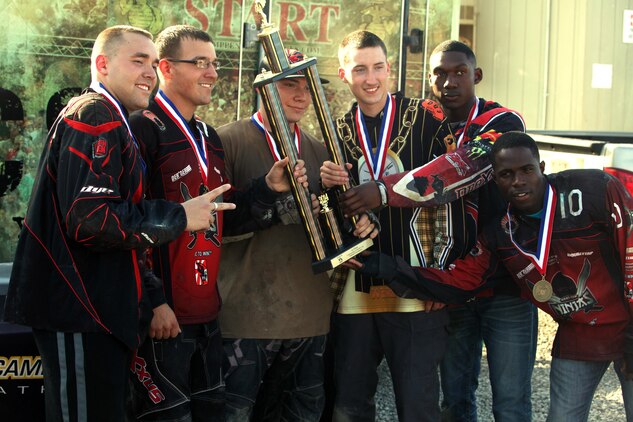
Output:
[218,45,375,421]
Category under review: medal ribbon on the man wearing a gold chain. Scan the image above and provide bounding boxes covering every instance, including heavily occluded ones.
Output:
[356,94,396,180]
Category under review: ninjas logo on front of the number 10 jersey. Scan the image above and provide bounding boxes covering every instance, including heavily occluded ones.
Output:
[528,259,604,319]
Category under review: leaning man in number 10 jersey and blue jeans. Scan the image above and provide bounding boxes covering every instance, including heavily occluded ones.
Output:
[360,132,633,422]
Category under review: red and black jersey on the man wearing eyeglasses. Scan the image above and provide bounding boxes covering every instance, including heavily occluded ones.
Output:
[130,95,277,324]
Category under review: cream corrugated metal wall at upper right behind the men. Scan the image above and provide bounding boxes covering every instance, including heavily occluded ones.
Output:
[475,0,633,132]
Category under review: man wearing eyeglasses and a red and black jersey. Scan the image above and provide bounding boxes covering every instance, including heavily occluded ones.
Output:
[130,25,302,421]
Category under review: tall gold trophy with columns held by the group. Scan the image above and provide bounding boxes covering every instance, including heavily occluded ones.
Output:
[253,0,373,273]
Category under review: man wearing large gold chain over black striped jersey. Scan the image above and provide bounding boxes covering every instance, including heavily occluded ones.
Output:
[321,31,476,422]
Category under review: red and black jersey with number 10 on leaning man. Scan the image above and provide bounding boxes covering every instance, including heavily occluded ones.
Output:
[390,170,633,361]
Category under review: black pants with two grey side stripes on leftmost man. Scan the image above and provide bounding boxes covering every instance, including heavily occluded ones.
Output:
[33,330,132,422]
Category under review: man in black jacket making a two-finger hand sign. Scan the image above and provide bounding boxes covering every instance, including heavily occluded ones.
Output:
[5,26,223,421]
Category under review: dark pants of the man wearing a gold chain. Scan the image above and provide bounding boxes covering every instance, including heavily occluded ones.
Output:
[332,309,448,422]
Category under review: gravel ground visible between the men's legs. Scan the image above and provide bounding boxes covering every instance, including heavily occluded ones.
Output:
[376,311,626,422]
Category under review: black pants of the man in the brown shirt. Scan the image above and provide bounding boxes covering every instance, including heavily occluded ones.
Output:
[224,335,325,422]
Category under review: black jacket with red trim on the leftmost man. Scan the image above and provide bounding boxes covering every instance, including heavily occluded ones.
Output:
[5,91,186,348]
